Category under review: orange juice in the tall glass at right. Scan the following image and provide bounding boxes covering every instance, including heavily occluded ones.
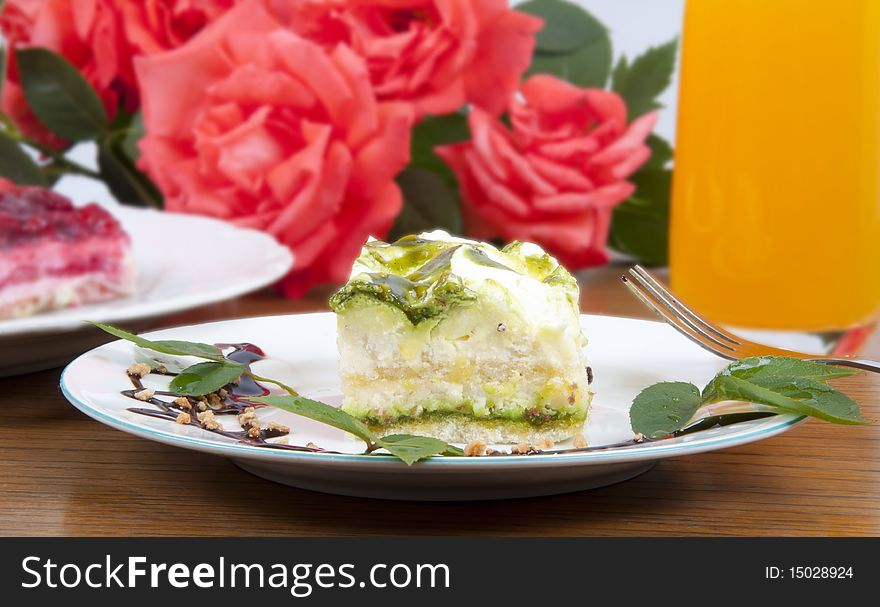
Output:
[670,0,880,330]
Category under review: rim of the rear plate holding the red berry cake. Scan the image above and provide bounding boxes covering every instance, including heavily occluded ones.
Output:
[0,205,295,339]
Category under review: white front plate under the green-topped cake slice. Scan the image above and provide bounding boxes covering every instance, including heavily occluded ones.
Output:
[61,313,802,500]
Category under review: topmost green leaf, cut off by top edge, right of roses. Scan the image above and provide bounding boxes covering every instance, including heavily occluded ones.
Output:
[516,0,608,53]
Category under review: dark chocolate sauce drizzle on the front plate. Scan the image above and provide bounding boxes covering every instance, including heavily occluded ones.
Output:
[121,343,775,457]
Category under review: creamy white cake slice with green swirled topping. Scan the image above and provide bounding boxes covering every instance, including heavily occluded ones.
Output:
[330,231,592,443]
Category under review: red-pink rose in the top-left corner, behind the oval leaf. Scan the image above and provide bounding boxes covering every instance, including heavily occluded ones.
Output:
[0,0,235,148]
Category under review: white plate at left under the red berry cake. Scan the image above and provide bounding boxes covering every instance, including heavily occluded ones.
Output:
[0,206,293,377]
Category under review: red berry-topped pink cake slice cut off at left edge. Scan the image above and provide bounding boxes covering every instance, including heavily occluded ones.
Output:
[0,180,134,318]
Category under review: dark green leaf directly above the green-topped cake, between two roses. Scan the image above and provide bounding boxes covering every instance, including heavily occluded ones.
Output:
[388,167,462,242]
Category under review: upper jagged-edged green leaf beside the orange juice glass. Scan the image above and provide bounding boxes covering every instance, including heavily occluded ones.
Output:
[611,39,678,119]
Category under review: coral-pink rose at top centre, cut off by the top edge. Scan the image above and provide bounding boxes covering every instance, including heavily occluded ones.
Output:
[265,0,543,116]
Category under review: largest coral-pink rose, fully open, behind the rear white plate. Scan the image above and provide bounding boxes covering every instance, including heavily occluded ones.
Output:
[136,0,412,296]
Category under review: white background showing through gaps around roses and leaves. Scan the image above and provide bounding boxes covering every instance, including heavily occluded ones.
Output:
[57,0,684,207]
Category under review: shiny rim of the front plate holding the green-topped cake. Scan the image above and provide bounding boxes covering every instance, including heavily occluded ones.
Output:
[59,312,806,470]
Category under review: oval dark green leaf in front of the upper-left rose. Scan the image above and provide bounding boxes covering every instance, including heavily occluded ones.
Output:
[15,48,107,141]
